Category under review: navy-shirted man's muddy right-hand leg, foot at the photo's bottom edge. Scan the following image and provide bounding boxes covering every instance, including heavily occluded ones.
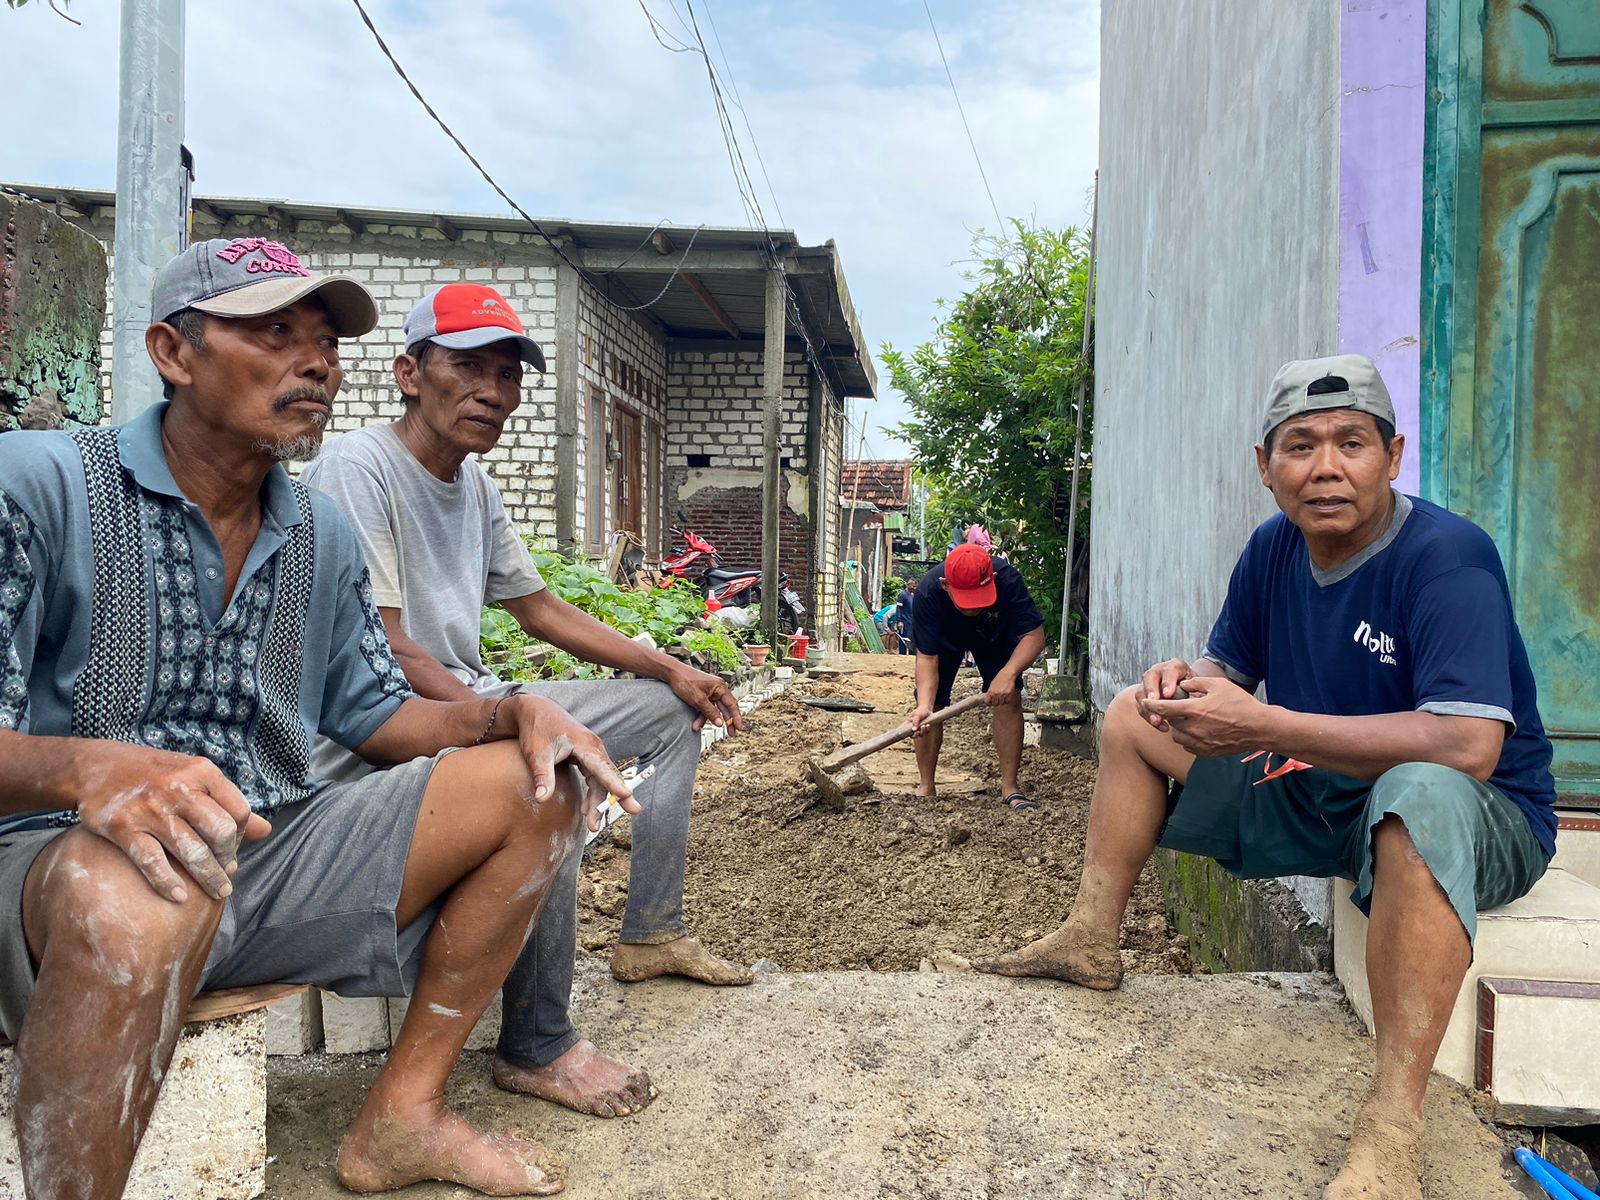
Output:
[1323,816,1472,1200]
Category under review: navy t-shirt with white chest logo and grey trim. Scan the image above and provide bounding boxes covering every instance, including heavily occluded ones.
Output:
[1205,494,1555,854]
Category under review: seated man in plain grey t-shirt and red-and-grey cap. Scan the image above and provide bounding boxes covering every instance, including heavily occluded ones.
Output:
[304,283,752,1117]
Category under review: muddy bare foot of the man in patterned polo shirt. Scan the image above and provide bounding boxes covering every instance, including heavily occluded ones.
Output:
[334,1109,566,1195]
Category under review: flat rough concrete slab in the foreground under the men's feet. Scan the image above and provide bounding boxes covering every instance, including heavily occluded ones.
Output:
[267,971,1518,1200]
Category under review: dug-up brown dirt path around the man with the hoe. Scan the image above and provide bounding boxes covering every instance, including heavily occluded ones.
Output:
[579,654,1194,974]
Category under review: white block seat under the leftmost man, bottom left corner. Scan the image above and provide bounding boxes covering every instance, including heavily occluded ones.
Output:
[0,1010,267,1200]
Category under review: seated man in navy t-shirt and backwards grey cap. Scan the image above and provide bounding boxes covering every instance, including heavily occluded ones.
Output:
[978,355,1555,1200]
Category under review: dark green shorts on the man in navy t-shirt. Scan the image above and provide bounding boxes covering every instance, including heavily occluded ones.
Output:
[1158,752,1549,939]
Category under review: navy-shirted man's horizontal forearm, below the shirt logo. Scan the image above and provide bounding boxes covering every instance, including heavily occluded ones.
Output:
[1261,706,1506,779]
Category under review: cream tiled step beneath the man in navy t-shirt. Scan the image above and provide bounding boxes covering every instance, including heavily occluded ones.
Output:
[1333,867,1600,1125]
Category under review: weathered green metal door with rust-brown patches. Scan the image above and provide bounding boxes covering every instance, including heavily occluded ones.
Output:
[1422,0,1600,803]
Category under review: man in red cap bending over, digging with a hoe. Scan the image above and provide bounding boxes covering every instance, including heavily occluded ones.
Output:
[909,542,1045,813]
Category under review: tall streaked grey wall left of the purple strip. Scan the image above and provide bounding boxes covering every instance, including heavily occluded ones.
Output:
[1090,0,1339,709]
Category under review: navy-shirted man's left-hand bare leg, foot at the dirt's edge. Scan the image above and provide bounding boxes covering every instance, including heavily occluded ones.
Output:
[973,688,1194,990]
